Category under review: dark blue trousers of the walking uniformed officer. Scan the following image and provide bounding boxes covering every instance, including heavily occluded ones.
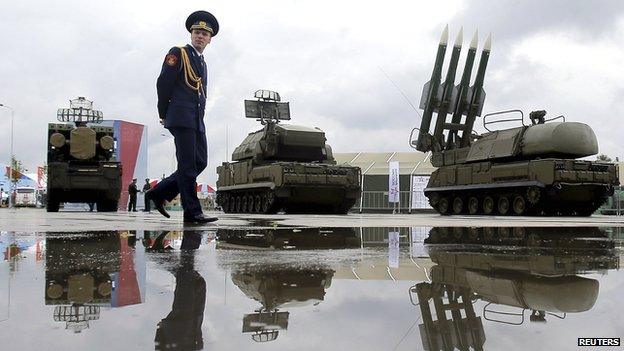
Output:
[152,128,208,217]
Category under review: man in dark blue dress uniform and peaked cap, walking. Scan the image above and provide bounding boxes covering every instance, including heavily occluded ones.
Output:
[146,11,219,223]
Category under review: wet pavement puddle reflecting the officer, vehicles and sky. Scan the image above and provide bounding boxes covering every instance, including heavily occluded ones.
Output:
[0,224,624,350]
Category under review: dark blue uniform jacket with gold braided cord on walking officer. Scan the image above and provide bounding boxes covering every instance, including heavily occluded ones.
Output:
[156,44,208,132]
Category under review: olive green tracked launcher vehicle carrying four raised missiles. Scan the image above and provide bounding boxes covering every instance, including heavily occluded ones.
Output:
[410,28,619,216]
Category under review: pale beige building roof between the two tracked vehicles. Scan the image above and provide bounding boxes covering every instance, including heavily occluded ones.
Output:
[334,151,435,175]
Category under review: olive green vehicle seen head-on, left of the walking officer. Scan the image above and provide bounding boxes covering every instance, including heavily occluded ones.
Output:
[46,97,121,212]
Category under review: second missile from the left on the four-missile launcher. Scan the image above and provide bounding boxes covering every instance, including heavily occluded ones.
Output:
[433,28,464,150]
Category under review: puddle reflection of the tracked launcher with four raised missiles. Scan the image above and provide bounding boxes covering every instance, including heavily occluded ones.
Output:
[410,228,619,350]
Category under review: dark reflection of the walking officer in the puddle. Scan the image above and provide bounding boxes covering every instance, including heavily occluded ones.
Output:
[154,231,206,350]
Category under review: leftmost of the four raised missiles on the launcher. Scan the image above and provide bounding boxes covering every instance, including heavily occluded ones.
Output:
[416,25,448,152]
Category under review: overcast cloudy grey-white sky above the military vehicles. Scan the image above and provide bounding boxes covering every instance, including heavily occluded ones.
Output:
[0,0,624,187]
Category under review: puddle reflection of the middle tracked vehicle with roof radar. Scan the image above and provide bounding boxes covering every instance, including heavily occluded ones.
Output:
[217,228,338,342]
